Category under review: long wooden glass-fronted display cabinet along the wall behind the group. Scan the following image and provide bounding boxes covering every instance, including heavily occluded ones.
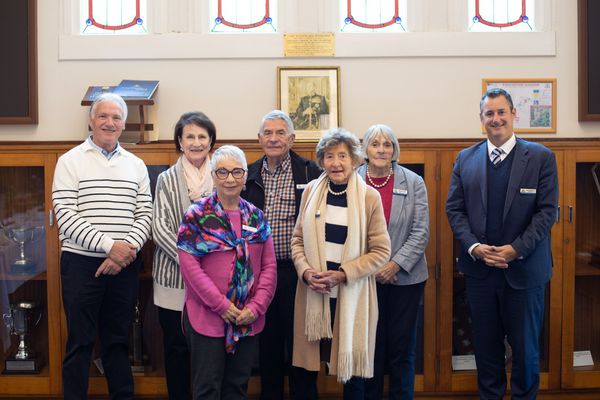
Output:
[0,139,600,398]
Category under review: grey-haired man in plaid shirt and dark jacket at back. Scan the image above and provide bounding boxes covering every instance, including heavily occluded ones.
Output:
[242,110,321,400]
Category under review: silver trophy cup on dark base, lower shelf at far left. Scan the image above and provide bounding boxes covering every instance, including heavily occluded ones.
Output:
[3,301,42,374]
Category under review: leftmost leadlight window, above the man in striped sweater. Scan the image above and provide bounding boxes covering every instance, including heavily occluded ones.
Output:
[79,0,148,35]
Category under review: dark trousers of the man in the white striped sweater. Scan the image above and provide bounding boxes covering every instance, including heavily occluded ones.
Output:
[60,251,142,400]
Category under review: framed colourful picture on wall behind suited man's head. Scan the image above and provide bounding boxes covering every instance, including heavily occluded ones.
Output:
[482,79,556,133]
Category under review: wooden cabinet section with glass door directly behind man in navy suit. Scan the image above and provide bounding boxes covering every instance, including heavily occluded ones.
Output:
[438,149,563,392]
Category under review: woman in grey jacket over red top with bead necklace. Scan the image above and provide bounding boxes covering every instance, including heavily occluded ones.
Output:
[358,125,429,399]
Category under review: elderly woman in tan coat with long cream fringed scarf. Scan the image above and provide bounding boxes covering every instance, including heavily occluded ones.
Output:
[291,129,390,399]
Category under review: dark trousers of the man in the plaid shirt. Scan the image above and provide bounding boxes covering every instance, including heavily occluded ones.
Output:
[259,260,298,400]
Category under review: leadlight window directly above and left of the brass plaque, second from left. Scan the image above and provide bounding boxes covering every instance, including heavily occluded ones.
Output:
[209,0,277,33]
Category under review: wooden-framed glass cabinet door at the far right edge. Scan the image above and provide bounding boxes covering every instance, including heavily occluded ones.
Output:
[562,150,600,388]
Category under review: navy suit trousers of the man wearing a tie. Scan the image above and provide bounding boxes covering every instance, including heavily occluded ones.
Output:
[465,268,544,400]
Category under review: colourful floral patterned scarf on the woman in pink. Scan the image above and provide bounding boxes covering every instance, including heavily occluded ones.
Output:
[177,193,271,353]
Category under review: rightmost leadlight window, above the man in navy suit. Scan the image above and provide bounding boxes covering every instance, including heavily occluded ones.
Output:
[469,0,535,32]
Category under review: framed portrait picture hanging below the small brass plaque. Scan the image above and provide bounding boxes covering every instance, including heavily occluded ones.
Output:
[277,67,340,141]
